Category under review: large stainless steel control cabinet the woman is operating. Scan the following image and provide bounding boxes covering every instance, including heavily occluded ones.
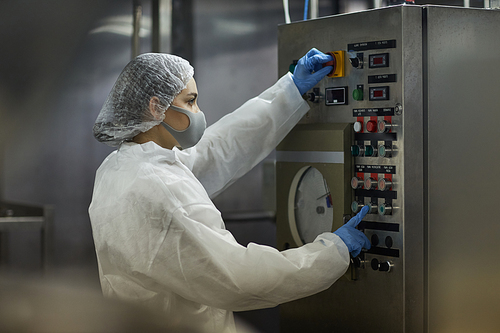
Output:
[276,5,500,333]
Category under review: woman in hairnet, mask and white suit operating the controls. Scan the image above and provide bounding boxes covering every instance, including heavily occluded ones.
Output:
[89,49,370,332]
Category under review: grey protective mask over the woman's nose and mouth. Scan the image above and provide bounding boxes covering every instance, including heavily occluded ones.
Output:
[161,105,207,149]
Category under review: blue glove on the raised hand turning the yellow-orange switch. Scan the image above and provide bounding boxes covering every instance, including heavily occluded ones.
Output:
[292,48,333,95]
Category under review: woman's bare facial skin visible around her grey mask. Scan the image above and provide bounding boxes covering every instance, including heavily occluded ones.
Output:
[163,78,200,131]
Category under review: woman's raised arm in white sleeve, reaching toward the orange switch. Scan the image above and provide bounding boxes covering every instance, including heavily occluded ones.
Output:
[177,73,309,197]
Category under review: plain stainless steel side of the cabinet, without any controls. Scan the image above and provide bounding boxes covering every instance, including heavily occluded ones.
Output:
[427,7,500,332]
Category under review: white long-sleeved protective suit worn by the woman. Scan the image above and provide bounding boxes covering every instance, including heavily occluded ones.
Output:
[89,74,349,332]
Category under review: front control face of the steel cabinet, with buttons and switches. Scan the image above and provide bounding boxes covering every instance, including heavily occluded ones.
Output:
[276,3,421,332]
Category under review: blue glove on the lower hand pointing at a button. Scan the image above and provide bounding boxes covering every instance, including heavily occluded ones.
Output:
[333,206,371,257]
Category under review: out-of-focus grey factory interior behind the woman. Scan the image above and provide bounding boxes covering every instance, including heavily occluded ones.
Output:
[0,0,492,332]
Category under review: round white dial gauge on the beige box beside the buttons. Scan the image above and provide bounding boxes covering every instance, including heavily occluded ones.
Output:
[288,166,333,246]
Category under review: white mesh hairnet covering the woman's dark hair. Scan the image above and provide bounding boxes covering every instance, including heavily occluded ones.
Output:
[93,53,194,147]
